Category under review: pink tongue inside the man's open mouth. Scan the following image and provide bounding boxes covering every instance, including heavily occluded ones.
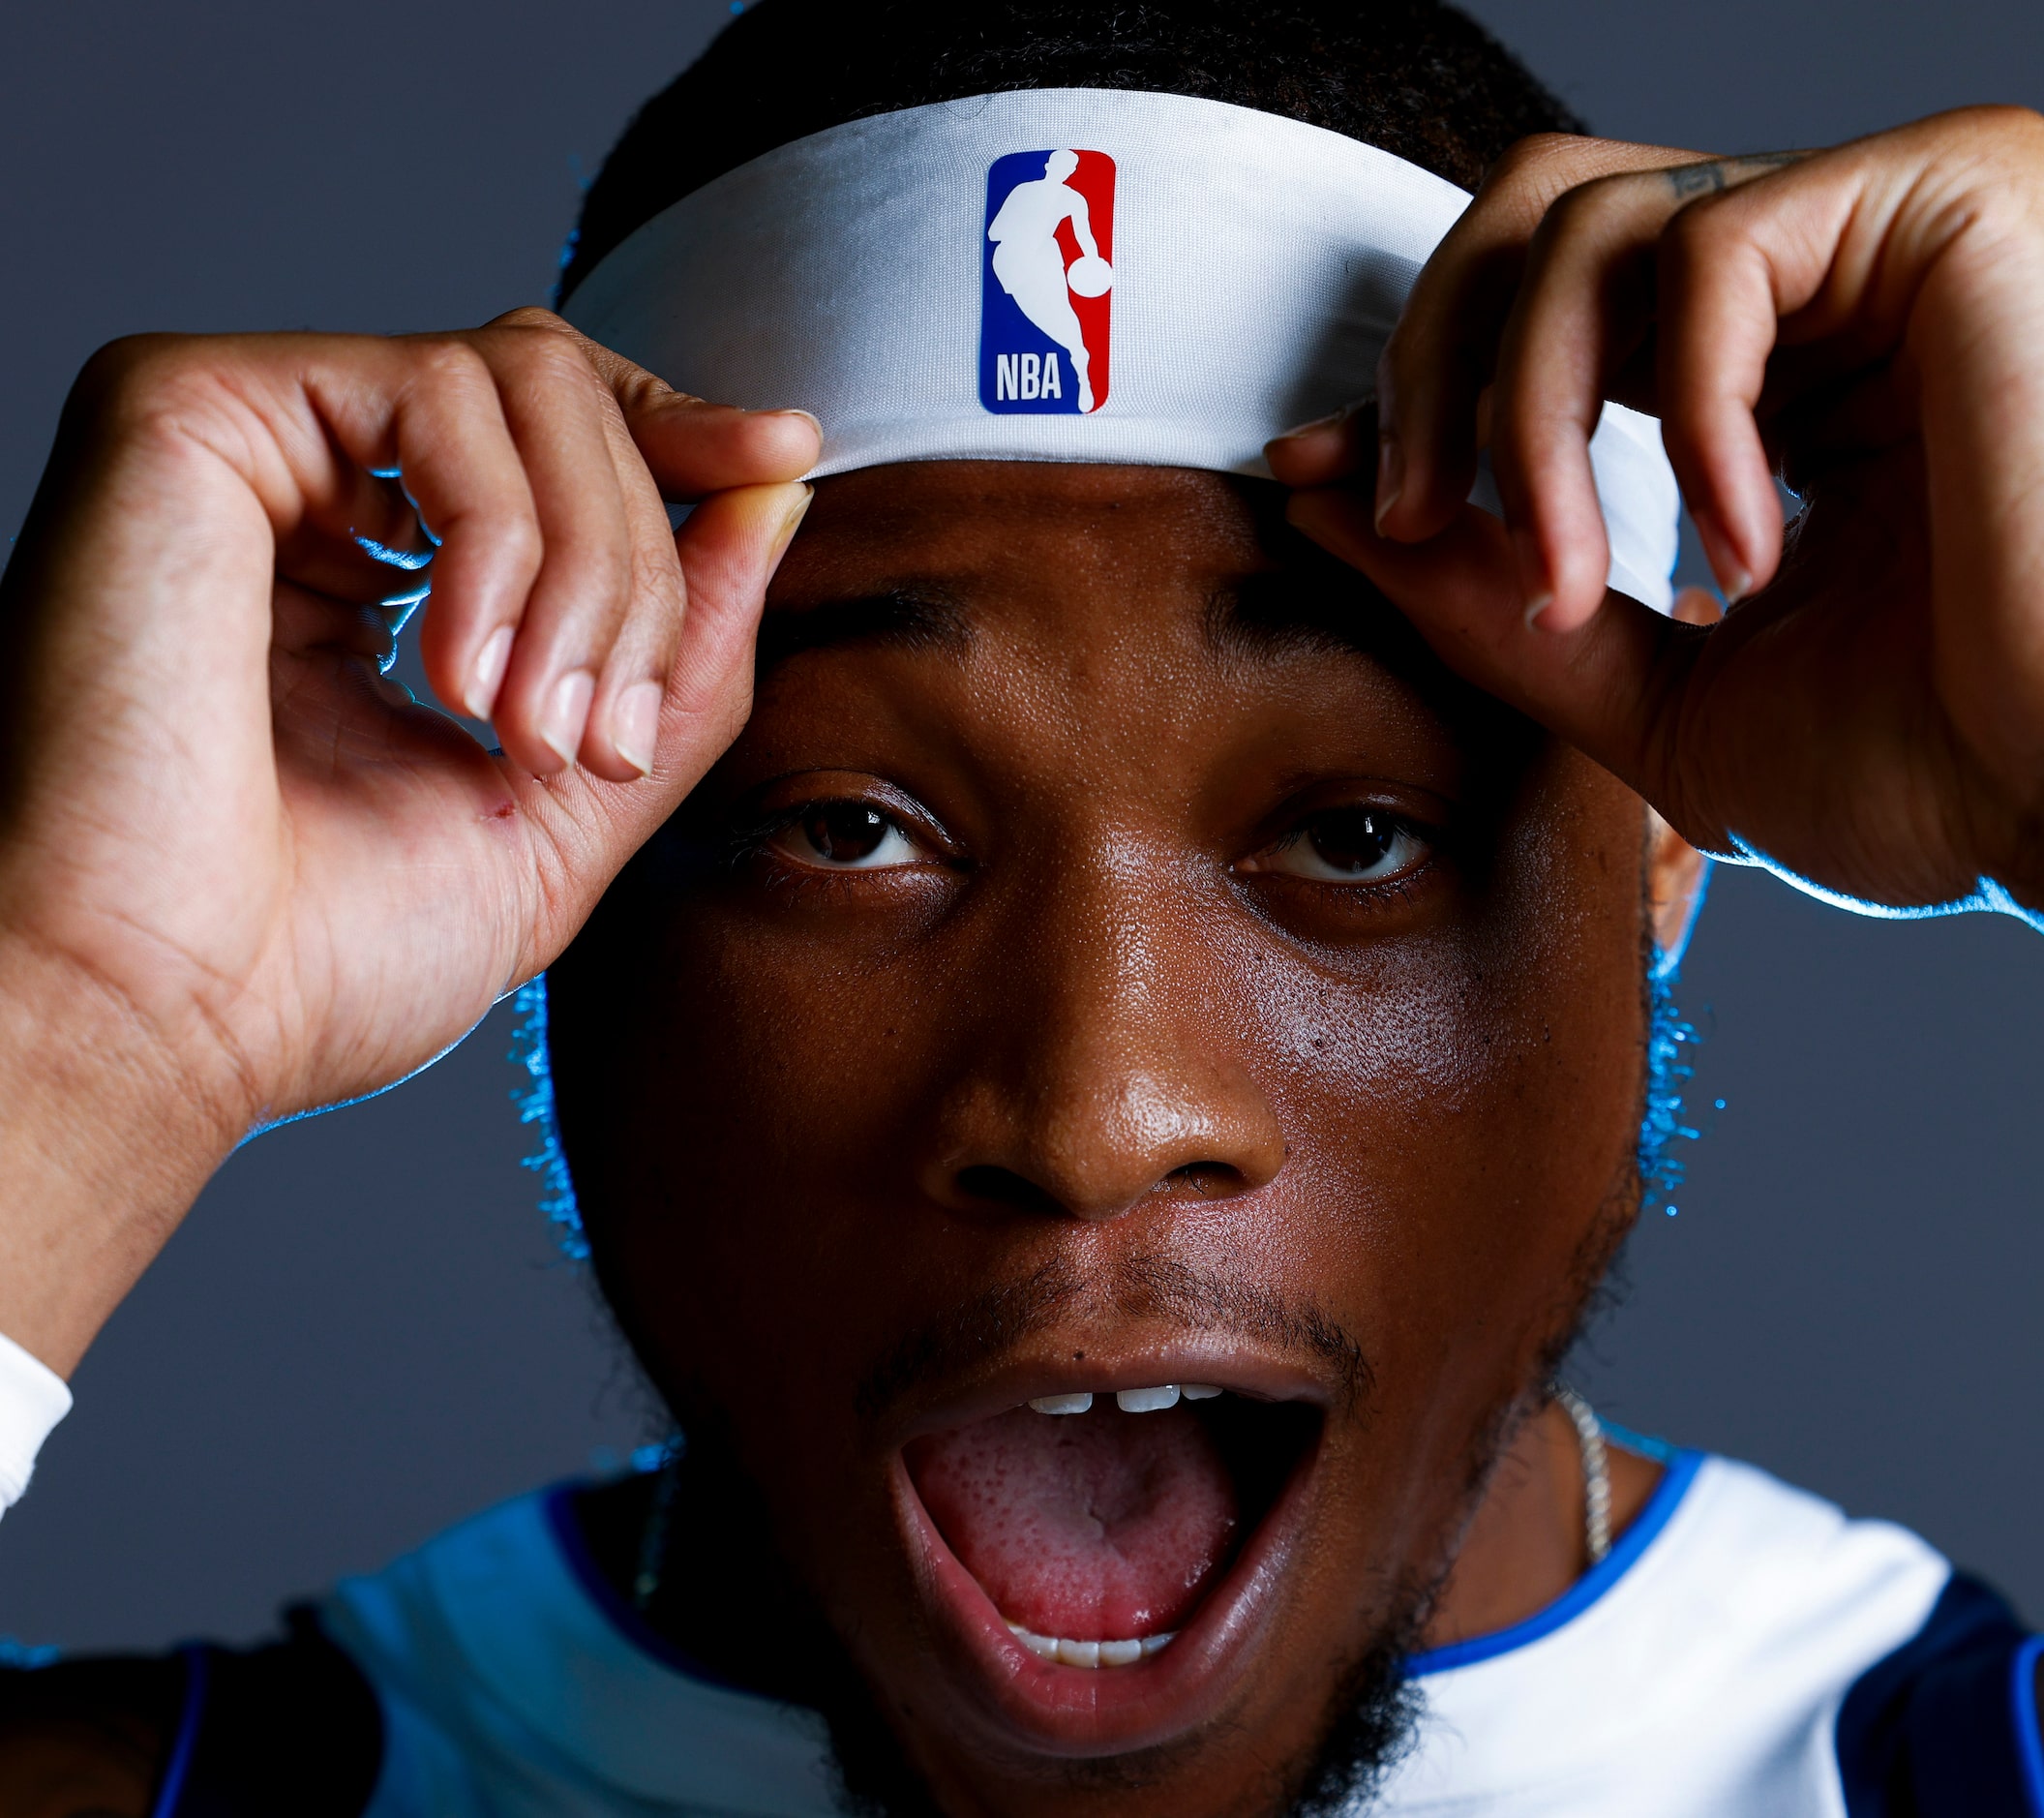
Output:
[908,1403,1237,1642]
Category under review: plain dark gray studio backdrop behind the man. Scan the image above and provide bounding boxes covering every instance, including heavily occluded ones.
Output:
[0,0,2044,1647]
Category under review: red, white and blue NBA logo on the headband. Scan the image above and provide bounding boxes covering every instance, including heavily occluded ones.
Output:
[979,151,1114,417]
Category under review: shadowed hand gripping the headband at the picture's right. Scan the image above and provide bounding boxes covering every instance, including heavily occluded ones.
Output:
[1272,108,2044,910]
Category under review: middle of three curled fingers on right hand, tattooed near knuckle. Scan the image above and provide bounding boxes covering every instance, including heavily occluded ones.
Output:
[1492,160,1807,632]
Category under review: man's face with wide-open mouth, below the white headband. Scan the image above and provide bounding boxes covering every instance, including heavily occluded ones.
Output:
[556,465,1643,1814]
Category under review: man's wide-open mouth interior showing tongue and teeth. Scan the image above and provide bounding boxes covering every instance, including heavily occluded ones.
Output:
[904,1382,1320,1671]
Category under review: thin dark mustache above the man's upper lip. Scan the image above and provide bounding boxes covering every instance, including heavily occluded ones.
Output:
[853,1254,1375,1419]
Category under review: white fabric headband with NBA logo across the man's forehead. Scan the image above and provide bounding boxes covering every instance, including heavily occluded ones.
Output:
[566,88,1678,612]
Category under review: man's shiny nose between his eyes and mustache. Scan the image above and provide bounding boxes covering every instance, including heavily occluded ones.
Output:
[924,863,1285,1223]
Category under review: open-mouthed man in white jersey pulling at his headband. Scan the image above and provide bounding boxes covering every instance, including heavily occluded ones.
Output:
[0,0,2044,1818]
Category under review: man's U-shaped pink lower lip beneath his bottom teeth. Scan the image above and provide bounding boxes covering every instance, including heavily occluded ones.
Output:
[893,1414,1322,1759]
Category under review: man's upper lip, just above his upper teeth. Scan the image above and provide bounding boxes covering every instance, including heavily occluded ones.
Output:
[883,1338,1338,1448]
